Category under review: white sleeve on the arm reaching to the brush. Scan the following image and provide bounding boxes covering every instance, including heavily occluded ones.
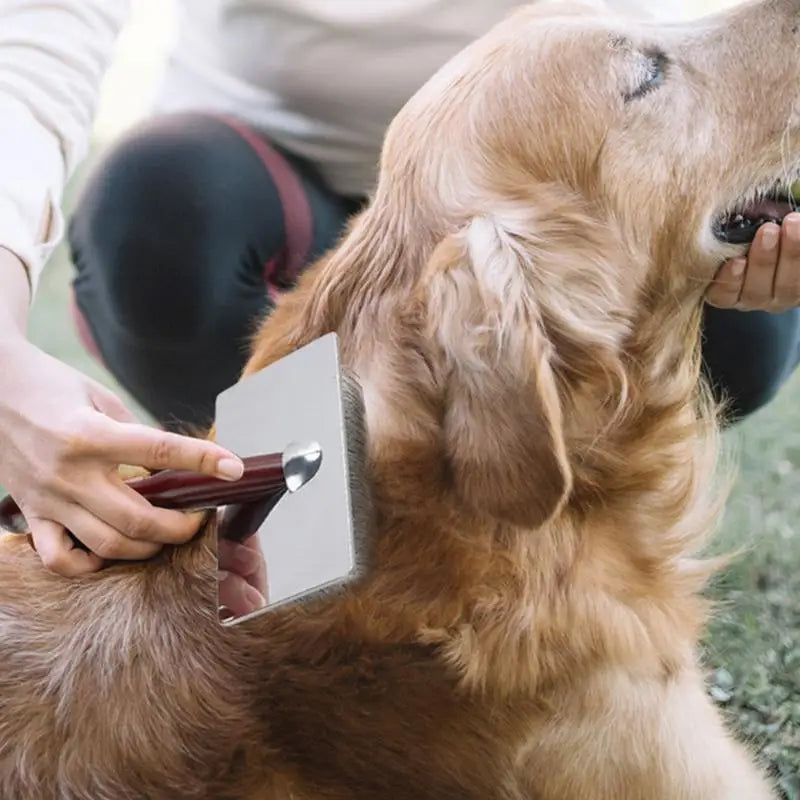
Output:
[0,0,129,287]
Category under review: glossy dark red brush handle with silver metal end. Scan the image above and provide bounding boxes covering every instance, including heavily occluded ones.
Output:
[0,442,322,543]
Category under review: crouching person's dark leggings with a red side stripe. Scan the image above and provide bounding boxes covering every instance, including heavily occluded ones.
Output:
[69,114,800,429]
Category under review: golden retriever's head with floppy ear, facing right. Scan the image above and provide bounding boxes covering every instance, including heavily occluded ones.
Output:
[247,0,800,528]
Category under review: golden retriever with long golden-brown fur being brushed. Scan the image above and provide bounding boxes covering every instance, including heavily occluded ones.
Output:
[0,0,800,800]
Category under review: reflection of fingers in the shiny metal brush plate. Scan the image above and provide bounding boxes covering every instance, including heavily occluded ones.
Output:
[217,535,268,617]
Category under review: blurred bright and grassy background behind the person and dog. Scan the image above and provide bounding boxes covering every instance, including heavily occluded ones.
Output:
[21,0,800,800]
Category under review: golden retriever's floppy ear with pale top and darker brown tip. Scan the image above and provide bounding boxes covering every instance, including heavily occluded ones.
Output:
[424,218,571,528]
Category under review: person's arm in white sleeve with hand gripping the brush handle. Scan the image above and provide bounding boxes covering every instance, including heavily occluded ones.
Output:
[0,0,242,575]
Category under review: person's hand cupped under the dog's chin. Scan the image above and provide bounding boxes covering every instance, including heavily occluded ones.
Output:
[706,212,800,312]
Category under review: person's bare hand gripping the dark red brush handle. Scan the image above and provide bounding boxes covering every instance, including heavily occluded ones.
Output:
[0,336,243,576]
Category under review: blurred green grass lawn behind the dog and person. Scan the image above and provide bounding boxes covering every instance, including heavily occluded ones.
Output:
[30,183,800,800]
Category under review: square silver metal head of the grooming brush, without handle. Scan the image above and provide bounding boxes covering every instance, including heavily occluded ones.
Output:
[216,334,371,624]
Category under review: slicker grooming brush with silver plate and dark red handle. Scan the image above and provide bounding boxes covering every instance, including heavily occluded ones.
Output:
[0,333,372,623]
